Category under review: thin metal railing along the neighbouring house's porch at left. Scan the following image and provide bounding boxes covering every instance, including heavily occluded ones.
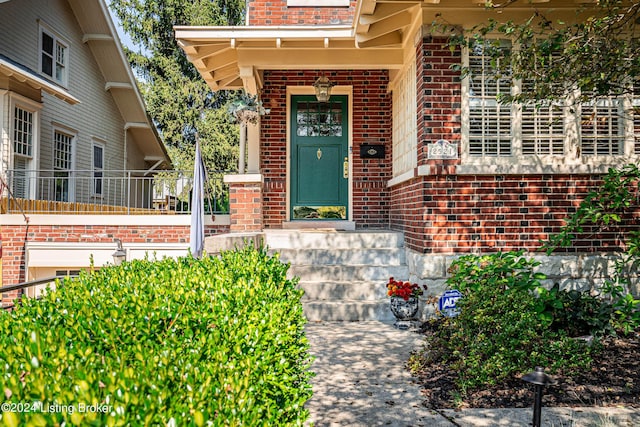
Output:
[0,170,229,215]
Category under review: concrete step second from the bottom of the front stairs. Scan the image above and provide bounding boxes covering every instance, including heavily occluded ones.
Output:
[298,281,387,302]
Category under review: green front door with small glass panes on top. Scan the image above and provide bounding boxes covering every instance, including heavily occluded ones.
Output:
[291,95,349,220]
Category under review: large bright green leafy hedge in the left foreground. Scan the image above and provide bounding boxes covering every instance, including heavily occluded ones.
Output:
[0,249,311,427]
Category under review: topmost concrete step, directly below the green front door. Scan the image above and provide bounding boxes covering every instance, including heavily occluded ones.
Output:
[264,230,404,250]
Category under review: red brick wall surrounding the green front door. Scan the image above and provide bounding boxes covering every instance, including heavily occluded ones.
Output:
[260,71,391,228]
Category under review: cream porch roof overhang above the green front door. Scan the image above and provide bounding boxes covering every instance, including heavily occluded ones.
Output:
[175,26,412,93]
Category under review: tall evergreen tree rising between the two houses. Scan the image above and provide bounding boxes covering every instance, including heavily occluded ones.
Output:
[110,0,245,171]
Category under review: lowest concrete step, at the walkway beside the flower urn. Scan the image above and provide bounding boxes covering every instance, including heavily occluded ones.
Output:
[303,299,395,322]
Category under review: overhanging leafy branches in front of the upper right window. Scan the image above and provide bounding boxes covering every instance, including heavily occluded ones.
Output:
[434,0,640,102]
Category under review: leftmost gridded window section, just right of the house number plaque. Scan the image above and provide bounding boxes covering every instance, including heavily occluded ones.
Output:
[468,41,513,157]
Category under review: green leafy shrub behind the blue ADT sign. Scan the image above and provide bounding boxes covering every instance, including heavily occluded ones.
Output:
[425,252,592,393]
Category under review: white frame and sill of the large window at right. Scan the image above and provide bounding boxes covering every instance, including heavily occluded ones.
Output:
[458,40,640,174]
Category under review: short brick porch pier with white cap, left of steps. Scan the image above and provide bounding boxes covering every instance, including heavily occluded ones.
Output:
[224,173,262,233]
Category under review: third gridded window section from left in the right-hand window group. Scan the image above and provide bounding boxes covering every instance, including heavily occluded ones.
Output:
[580,97,624,156]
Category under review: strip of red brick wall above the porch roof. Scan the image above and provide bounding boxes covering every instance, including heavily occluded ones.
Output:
[247,0,356,26]
